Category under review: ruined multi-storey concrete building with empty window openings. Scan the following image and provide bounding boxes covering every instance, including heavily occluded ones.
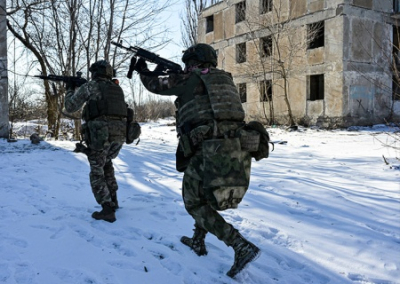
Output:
[198,0,400,127]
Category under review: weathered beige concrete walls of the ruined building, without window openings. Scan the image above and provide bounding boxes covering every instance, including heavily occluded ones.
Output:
[198,0,400,127]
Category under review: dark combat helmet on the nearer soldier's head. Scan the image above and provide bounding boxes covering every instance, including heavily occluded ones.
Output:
[182,43,218,67]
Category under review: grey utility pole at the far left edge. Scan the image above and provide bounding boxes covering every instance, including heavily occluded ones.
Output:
[0,0,9,138]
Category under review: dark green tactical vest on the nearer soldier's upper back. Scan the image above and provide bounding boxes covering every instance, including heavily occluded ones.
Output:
[178,68,245,126]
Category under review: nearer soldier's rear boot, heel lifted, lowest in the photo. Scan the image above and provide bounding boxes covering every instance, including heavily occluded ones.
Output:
[226,233,261,278]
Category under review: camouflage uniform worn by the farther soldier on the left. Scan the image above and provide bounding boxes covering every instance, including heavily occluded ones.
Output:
[65,61,126,222]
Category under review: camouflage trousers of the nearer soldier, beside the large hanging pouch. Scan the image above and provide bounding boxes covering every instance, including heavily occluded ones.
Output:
[182,151,238,246]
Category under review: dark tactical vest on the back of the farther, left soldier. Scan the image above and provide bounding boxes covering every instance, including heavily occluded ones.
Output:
[82,81,127,121]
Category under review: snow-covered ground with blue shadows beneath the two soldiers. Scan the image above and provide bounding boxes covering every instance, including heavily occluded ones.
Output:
[0,119,400,284]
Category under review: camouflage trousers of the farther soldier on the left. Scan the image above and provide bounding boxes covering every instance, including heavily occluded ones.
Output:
[88,142,122,204]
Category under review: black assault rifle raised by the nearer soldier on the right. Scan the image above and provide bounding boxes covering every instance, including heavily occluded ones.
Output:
[111,41,182,79]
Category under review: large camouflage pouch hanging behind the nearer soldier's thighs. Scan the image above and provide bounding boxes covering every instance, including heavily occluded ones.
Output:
[202,138,251,210]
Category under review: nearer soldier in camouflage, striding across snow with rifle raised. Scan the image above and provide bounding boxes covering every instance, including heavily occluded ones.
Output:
[131,44,260,278]
